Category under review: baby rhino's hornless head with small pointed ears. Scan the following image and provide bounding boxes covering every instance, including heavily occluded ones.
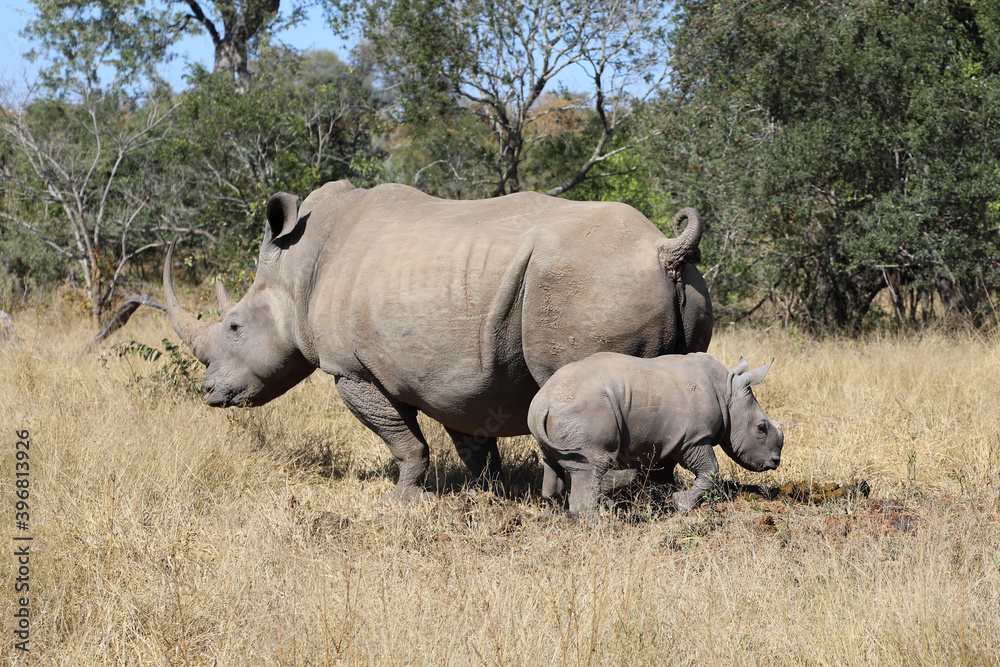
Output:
[722,357,785,472]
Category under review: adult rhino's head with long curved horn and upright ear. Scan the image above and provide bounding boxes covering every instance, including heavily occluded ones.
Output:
[163,193,314,407]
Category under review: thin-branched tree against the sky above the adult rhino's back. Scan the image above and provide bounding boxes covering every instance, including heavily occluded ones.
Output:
[327,0,665,196]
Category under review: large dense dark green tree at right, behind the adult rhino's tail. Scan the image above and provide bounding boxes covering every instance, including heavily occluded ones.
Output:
[650,0,1000,330]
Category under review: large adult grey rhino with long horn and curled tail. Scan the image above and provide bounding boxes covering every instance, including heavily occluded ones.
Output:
[163,181,712,499]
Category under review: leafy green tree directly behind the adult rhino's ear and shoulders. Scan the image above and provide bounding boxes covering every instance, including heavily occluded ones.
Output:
[161,49,384,286]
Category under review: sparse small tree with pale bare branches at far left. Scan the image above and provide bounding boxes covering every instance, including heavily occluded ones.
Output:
[0,84,190,326]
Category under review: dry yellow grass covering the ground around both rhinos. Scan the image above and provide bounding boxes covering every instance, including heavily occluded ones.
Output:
[0,310,1000,665]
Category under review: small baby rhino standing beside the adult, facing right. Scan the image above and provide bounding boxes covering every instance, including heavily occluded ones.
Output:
[528,352,784,518]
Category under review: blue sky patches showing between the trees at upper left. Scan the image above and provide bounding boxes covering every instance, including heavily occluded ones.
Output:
[0,0,350,90]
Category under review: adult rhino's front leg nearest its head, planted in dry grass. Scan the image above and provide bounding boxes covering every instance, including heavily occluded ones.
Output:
[337,377,434,501]
